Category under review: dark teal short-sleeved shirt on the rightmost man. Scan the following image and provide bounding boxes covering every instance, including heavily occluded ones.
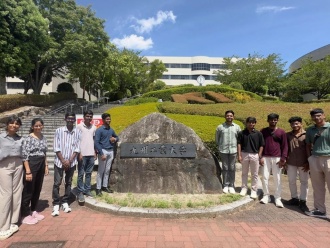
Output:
[306,122,330,156]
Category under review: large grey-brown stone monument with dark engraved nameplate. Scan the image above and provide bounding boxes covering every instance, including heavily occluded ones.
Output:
[110,113,222,194]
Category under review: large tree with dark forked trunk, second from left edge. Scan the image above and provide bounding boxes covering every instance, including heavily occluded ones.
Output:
[21,0,109,94]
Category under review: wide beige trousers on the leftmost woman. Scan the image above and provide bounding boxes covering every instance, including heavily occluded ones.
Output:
[0,157,23,231]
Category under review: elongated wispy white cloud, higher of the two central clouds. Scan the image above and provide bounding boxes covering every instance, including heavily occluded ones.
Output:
[132,10,176,34]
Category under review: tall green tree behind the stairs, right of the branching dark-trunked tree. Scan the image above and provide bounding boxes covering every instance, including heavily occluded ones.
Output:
[63,7,109,100]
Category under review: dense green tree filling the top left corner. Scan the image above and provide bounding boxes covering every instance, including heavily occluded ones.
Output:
[0,0,48,93]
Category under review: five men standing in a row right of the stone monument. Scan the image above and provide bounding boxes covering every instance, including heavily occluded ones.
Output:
[215,108,330,218]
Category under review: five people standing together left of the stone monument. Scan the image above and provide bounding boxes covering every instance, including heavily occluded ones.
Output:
[0,110,119,240]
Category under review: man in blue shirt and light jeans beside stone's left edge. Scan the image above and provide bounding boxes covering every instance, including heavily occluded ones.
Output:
[94,113,119,195]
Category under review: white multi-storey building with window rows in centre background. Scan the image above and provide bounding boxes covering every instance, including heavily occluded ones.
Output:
[145,56,232,86]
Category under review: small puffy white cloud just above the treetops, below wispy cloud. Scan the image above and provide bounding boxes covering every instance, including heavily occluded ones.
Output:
[112,34,153,50]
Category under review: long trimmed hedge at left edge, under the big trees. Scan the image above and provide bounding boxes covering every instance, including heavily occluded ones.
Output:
[0,92,77,112]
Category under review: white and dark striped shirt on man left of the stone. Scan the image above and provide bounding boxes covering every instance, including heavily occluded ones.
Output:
[54,126,81,168]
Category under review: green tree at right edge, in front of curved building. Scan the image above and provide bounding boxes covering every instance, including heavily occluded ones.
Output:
[286,55,330,99]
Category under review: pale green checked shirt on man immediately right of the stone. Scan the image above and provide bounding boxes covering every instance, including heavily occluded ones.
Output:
[215,122,241,154]
